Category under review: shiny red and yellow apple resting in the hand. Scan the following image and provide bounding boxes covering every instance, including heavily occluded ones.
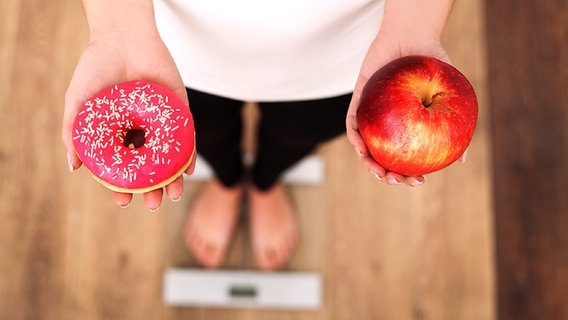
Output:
[357,56,478,176]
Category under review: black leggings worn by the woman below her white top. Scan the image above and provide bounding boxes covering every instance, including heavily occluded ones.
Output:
[187,89,351,190]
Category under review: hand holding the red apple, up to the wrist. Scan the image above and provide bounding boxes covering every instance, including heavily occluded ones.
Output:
[346,32,465,186]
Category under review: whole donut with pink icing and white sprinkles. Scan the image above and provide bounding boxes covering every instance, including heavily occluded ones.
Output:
[73,80,195,193]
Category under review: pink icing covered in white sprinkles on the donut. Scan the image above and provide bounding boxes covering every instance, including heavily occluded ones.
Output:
[73,81,193,185]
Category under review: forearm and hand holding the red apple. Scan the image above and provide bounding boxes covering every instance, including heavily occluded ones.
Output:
[346,0,453,186]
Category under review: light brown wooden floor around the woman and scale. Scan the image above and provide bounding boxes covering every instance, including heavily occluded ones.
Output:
[0,0,496,320]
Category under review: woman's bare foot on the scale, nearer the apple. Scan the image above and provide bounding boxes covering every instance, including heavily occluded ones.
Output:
[249,183,298,270]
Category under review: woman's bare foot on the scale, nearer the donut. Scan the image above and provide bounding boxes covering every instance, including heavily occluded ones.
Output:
[185,179,243,268]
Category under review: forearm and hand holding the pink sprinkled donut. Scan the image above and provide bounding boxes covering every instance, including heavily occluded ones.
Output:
[61,0,194,210]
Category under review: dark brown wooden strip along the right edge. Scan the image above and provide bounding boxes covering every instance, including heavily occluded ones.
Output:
[486,0,568,320]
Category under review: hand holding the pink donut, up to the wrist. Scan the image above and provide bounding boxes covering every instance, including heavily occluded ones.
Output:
[61,28,195,212]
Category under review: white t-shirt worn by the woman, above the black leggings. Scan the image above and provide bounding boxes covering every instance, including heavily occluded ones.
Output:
[154,0,384,101]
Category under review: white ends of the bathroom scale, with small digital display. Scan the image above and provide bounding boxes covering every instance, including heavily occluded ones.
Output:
[163,155,324,310]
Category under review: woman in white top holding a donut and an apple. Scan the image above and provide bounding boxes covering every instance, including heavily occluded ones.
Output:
[62,0,458,270]
